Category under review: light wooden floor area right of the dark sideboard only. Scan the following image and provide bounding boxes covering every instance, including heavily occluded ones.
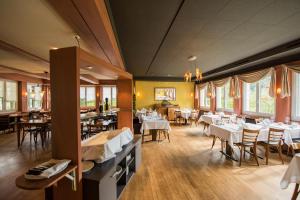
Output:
[121,127,294,200]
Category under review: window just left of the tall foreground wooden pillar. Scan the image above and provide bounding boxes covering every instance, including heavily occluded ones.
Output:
[27,83,44,110]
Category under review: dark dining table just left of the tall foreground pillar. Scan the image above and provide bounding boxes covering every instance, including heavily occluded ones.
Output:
[17,118,51,148]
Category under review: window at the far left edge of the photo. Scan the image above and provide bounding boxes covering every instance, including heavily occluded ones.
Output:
[0,80,18,112]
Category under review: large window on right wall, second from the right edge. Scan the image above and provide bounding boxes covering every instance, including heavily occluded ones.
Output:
[243,76,275,115]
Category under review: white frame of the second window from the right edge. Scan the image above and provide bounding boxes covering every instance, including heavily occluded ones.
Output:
[242,75,276,117]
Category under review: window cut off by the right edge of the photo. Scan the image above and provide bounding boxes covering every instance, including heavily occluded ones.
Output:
[292,72,300,121]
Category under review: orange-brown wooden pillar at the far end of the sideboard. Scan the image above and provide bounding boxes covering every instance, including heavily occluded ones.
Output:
[117,79,133,130]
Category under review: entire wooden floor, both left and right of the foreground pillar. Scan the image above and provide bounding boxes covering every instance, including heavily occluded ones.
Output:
[0,127,294,200]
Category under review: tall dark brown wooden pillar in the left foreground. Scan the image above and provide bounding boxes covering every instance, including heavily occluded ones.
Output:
[50,47,82,200]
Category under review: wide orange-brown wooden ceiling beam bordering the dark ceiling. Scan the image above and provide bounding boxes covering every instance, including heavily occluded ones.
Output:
[48,0,125,69]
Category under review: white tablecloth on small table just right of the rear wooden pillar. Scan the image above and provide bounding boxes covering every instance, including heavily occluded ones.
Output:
[140,119,171,133]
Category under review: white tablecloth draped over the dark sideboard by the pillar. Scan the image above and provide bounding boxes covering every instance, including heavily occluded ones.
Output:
[81,128,133,163]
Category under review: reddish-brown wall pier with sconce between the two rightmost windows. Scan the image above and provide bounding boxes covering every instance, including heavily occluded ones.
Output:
[275,67,292,122]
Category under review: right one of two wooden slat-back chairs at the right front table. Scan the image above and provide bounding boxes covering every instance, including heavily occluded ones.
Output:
[262,128,284,165]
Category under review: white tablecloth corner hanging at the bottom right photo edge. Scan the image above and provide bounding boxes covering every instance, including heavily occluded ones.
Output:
[280,153,300,189]
